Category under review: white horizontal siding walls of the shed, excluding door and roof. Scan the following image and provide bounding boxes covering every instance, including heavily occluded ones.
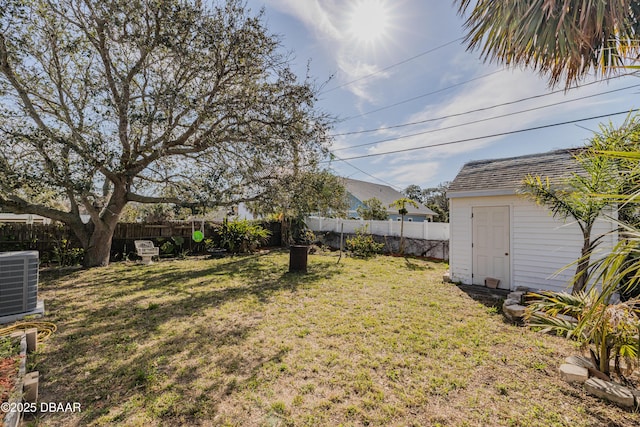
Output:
[449,195,617,291]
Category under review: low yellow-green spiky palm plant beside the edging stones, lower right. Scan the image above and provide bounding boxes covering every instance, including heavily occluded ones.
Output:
[525,288,640,377]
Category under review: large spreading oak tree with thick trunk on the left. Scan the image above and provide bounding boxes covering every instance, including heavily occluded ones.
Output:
[0,0,328,266]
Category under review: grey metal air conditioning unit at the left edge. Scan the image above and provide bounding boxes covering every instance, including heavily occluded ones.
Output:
[0,251,38,317]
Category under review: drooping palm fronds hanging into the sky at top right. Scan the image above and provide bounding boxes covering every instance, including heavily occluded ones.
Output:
[454,0,640,88]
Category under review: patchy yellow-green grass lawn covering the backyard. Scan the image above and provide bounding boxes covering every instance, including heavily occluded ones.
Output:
[31,252,640,427]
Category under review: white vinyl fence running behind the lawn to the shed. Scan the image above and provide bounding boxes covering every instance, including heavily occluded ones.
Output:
[305,217,449,240]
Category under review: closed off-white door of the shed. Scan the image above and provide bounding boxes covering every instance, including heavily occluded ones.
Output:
[471,206,511,289]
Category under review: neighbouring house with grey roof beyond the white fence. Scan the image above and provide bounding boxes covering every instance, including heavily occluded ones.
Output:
[343,178,437,222]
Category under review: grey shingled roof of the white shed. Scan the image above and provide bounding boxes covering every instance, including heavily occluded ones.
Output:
[447,148,582,197]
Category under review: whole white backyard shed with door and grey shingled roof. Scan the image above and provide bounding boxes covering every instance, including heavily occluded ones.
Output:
[447,150,617,291]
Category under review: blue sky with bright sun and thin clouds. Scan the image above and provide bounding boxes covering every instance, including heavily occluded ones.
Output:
[248,0,640,190]
